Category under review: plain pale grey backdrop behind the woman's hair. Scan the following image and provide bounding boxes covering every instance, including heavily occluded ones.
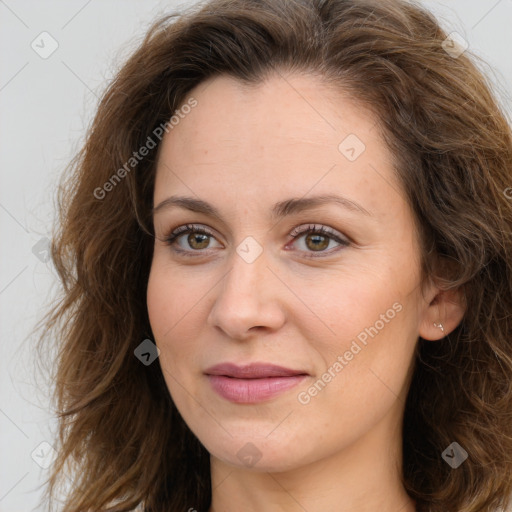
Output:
[0,0,512,512]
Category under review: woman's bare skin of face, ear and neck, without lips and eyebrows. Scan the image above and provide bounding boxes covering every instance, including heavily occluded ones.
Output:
[147,73,463,512]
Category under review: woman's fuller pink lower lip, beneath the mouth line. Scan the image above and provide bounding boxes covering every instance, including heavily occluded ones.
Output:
[208,375,307,404]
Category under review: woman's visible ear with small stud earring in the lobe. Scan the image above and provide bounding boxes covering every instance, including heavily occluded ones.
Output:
[418,276,466,341]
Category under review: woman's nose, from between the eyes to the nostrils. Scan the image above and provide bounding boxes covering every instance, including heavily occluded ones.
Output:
[208,247,286,340]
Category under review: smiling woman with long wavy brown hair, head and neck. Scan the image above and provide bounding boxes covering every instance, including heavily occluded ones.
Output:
[36,0,512,512]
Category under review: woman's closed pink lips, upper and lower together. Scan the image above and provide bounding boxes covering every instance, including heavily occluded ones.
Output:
[204,363,308,404]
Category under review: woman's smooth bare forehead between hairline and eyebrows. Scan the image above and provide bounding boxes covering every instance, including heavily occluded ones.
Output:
[154,75,397,216]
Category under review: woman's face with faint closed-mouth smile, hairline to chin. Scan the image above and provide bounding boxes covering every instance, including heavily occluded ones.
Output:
[147,75,436,471]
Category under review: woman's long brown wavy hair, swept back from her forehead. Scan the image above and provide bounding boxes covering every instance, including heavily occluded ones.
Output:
[38,0,512,512]
